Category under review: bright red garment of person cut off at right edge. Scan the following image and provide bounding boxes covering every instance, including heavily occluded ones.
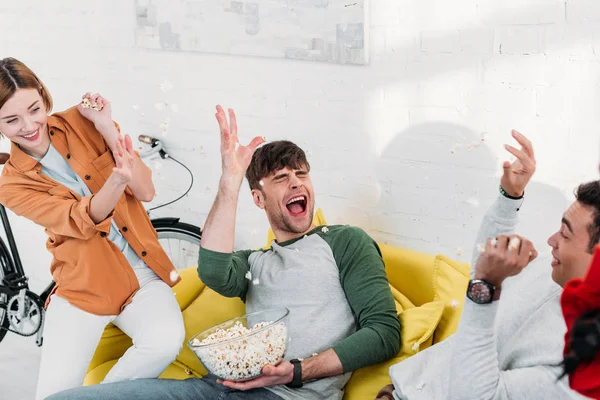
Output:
[561,246,600,399]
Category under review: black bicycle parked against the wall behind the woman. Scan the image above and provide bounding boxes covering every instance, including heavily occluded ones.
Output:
[0,135,202,346]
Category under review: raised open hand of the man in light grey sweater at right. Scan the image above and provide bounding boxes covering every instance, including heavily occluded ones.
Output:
[500,130,535,197]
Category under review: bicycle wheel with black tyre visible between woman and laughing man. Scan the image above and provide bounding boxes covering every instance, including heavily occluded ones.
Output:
[152,218,202,269]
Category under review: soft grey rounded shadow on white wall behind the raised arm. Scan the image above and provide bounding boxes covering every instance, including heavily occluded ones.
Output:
[367,122,569,262]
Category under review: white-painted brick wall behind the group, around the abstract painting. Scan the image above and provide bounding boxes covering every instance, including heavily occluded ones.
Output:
[0,0,600,296]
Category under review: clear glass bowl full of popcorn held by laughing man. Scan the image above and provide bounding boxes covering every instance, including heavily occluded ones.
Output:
[188,308,290,382]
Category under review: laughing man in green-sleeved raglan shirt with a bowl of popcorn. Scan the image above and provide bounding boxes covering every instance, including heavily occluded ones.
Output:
[51,107,400,400]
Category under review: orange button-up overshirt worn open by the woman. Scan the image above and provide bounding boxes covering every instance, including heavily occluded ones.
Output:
[0,107,180,315]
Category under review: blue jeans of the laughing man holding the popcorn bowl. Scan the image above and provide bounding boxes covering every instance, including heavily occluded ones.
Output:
[46,375,281,400]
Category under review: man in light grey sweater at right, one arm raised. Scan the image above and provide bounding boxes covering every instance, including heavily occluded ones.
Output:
[381,131,600,400]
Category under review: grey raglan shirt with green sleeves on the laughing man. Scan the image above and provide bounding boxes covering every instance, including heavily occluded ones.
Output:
[198,225,400,400]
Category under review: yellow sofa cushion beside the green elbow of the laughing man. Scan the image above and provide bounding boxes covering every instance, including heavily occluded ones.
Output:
[344,301,444,400]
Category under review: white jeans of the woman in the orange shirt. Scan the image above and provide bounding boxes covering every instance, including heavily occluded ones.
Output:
[36,279,185,400]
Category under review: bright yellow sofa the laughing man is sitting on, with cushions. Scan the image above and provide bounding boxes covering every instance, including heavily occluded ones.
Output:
[85,210,469,400]
